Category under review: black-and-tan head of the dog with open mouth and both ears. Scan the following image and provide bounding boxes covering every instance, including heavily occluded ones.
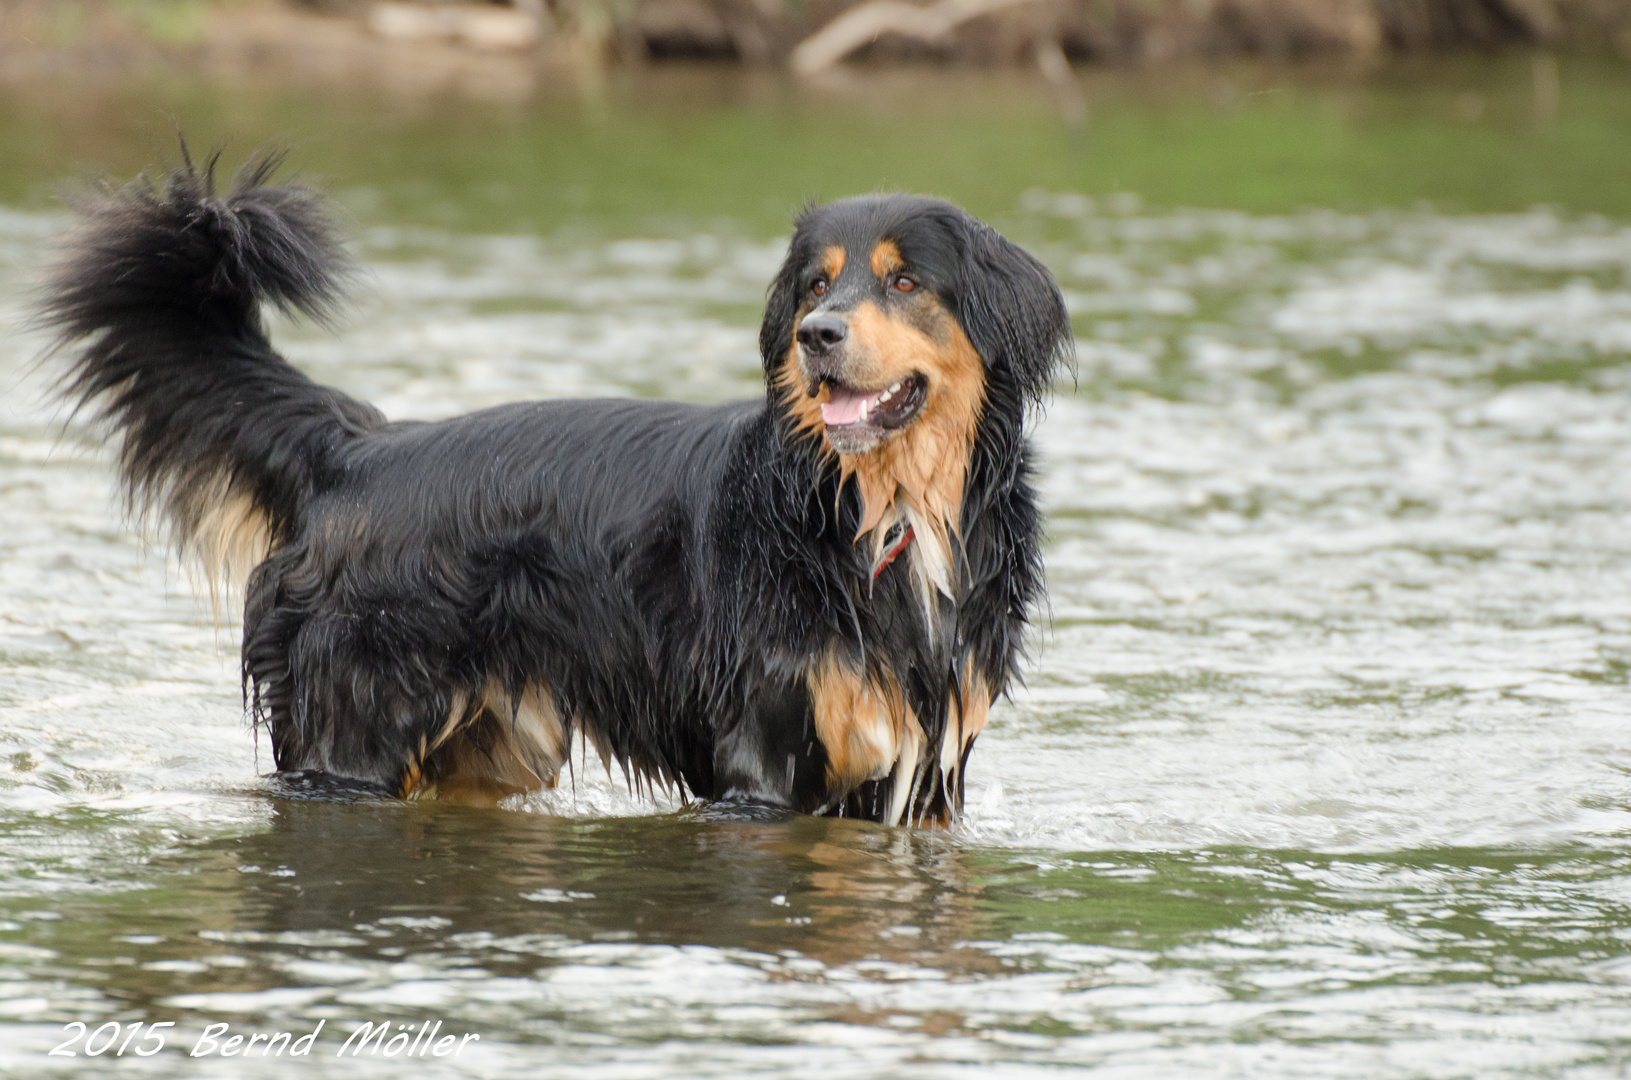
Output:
[758,196,1070,457]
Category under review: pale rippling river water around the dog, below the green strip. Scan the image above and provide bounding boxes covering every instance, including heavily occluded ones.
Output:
[0,63,1631,1080]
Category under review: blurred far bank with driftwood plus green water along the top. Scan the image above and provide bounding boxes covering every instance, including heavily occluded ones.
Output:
[0,0,1631,223]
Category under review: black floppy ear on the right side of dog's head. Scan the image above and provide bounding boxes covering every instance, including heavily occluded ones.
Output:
[957,217,1072,401]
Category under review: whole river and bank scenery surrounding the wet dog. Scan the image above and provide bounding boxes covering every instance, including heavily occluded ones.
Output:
[0,0,1631,1080]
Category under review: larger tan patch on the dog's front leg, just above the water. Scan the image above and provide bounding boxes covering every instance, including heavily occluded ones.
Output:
[809,654,915,793]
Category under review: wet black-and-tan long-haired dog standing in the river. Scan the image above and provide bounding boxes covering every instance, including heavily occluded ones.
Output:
[39,155,1073,824]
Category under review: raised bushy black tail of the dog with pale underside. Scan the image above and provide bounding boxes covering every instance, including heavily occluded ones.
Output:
[39,155,383,587]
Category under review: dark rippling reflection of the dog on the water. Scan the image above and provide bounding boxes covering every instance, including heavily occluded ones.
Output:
[212,803,988,971]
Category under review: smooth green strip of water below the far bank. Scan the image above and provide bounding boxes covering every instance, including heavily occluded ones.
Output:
[9,55,1631,235]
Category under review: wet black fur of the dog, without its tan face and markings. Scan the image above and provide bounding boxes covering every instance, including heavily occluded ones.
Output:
[41,160,1068,817]
